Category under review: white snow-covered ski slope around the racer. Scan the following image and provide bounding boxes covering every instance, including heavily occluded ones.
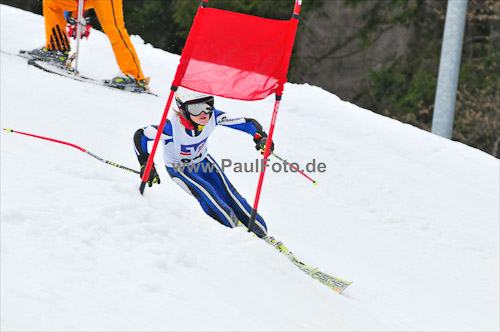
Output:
[0,5,500,331]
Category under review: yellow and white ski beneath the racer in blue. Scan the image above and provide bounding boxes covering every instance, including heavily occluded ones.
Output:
[264,236,352,294]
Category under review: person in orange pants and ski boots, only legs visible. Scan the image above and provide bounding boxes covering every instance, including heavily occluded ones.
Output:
[29,0,149,91]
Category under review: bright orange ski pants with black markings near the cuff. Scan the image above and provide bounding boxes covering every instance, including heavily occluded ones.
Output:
[43,0,144,80]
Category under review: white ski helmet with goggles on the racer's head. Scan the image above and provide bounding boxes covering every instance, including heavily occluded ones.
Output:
[175,87,214,122]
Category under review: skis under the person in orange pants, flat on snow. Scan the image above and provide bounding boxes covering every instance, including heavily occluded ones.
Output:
[14,50,158,97]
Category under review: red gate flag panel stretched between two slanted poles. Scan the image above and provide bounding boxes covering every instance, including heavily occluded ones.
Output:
[173,4,298,100]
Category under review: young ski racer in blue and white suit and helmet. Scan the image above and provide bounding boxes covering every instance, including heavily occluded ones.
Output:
[134,87,274,238]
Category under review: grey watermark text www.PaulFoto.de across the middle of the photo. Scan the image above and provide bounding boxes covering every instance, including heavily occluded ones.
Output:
[173,159,326,173]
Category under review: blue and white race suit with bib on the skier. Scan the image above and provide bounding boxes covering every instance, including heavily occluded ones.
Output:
[134,110,267,237]
